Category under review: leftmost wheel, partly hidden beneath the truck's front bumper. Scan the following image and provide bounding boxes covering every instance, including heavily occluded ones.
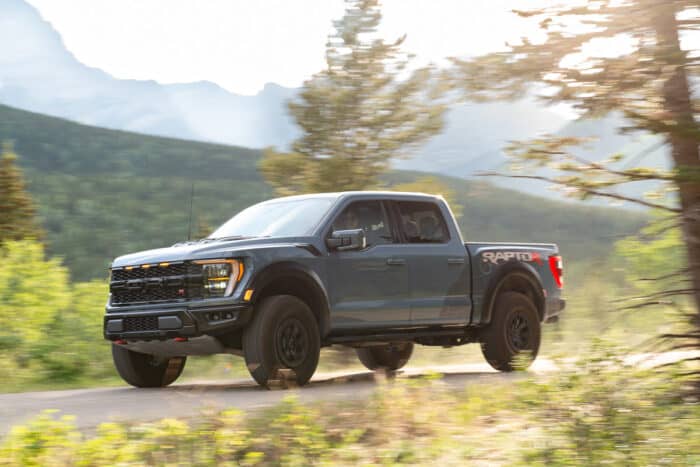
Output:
[112,344,187,388]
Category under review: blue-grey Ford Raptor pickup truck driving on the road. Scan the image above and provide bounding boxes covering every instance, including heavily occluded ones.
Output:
[104,192,565,387]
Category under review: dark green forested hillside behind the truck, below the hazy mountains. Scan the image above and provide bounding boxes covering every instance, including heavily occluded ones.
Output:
[0,105,644,279]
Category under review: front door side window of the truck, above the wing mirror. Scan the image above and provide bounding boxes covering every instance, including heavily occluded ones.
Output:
[333,201,394,247]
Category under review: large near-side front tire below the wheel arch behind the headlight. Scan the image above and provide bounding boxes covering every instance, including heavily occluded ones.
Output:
[243,295,321,387]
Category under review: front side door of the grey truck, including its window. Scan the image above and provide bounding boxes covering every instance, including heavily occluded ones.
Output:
[328,200,410,331]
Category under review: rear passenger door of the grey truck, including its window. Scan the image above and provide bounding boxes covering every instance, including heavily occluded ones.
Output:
[393,201,471,325]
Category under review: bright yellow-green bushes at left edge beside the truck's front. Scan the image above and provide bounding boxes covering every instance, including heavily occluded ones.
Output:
[0,240,112,390]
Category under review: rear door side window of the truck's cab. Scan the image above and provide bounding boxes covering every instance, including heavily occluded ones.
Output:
[397,201,450,243]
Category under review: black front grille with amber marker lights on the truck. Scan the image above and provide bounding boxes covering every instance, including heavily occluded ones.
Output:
[109,262,202,308]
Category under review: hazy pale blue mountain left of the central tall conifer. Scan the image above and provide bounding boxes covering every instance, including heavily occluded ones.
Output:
[0,0,295,147]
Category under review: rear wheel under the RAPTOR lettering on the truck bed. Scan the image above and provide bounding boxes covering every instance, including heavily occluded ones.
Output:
[481,292,541,371]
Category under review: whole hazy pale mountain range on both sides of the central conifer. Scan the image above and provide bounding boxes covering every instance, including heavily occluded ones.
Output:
[0,0,667,206]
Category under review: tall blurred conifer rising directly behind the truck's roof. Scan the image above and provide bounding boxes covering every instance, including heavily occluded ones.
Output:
[260,0,445,194]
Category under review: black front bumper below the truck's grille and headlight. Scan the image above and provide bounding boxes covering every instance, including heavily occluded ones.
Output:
[103,302,252,341]
